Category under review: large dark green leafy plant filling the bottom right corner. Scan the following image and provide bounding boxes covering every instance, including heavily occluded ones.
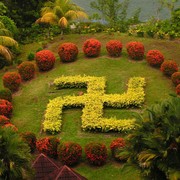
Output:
[120,96,180,180]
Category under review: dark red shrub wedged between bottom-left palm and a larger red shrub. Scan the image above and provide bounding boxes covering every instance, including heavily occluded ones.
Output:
[21,132,36,153]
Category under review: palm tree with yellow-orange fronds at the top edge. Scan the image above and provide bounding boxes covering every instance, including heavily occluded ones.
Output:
[36,0,88,34]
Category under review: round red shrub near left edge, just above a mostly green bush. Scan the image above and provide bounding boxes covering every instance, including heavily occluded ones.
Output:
[2,72,21,92]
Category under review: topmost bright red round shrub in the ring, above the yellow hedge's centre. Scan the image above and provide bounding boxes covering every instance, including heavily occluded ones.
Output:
[83,39,101,57]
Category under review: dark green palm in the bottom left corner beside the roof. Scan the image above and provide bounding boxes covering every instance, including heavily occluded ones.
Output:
[0,128,31,180]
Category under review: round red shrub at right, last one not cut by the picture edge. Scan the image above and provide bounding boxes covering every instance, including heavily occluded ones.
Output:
[161,60,178,76]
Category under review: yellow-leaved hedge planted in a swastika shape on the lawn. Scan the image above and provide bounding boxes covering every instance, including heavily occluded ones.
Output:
[43,76,145,133]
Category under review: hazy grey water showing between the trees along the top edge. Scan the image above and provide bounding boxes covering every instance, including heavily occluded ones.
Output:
[72,0,180,21]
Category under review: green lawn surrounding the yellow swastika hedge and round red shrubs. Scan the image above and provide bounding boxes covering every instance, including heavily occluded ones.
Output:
[0,33,180,180]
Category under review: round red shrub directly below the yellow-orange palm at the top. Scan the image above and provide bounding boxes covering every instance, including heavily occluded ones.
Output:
[58,43,78,62]
